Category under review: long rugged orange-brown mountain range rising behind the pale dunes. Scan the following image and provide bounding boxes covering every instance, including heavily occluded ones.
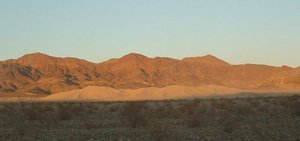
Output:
[0,53,300,94]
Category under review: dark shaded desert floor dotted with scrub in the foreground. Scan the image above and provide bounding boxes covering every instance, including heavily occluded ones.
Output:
[0,95,300,141]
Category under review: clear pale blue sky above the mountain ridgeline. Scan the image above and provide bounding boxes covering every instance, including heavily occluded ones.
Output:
[0,0,300,67]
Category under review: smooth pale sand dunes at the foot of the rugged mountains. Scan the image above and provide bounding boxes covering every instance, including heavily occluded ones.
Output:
[43,85,242,101]
